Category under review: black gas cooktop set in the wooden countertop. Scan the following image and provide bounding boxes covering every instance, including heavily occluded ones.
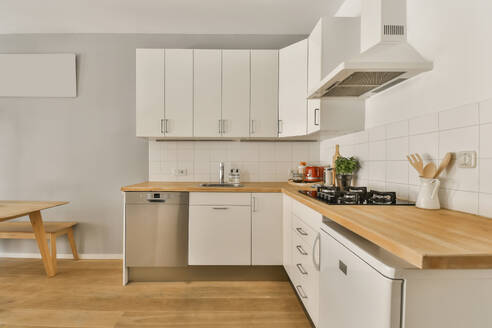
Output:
[299,186,415,205]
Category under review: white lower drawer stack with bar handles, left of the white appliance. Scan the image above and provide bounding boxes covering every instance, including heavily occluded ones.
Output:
[284,196,322,326]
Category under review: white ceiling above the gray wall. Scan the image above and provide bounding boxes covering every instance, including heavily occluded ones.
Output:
[0,0,343,34]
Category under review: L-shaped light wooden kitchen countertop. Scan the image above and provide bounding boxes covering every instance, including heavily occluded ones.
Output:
[121,182,492,269]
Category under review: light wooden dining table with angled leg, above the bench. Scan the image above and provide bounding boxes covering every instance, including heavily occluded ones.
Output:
[0,200,68,277]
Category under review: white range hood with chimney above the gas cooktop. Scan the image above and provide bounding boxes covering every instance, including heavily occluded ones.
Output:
[309,0,433,99]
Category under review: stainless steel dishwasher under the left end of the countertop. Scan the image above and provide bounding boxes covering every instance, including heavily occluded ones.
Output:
[125,192,189,267]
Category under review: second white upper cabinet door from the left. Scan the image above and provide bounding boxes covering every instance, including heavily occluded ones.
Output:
[164,49,193,137]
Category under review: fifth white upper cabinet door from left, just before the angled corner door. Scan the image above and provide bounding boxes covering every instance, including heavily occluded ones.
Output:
[250,50,278,138]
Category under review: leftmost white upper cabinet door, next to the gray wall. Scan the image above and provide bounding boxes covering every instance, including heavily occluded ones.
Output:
[135,49,164,137]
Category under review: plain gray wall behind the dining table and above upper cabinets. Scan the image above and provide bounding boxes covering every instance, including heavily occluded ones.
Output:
[0,34,305,254]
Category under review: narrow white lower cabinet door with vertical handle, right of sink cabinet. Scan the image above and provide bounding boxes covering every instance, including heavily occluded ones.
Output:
[251,193,282,265]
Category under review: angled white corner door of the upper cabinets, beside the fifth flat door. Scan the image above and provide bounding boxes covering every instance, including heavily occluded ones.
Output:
[279,39,308,137]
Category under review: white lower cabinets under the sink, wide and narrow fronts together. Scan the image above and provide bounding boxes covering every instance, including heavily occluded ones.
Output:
[188,192,282,265]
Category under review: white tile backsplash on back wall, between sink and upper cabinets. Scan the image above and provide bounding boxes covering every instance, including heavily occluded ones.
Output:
[149,141,320,182]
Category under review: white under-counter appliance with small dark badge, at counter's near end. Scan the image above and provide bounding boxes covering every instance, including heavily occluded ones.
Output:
[317,218,492,328]
